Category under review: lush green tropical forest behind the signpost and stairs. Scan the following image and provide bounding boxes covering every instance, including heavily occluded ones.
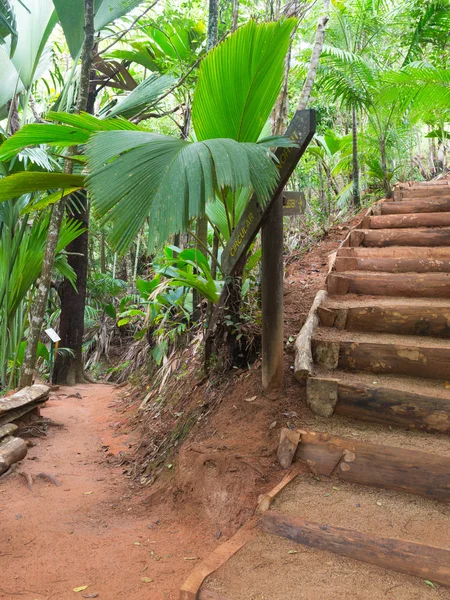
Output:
[0,0,450,391]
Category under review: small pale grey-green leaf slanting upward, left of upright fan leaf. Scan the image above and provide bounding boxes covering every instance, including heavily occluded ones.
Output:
[103,73,175,119]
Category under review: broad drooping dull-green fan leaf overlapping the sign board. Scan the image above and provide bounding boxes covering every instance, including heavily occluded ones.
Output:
[86,131,278,252]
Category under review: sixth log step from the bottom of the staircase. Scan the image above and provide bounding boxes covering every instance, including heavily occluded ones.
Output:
[327,271,450,298]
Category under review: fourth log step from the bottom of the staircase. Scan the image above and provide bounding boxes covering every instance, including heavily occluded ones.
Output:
[312,329,450,380]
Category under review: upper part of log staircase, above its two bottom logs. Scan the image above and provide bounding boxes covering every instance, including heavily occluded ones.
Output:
[307,182,450,432]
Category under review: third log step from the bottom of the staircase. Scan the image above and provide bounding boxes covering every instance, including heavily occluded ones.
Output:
[307,372,450,433]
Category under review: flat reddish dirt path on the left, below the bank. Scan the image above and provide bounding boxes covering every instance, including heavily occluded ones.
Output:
[0,385,217,600]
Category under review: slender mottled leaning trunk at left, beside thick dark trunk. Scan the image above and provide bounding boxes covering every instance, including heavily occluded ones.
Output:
[20,0,95,387]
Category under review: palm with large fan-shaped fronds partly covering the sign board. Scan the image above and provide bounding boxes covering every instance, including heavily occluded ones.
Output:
[0,19,295,252]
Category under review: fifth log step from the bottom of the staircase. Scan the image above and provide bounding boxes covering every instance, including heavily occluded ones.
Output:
[318,302,450,338]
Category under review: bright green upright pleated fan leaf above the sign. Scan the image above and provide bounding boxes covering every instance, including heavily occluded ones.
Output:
[192,19,296,142]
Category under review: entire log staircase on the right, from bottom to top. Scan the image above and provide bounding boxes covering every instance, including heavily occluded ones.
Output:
[192,182,450,600]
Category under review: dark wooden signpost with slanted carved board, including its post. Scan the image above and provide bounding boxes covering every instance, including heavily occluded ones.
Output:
[222,110,316,392]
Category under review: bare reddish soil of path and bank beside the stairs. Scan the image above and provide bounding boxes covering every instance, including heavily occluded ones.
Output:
[0,223,347,600]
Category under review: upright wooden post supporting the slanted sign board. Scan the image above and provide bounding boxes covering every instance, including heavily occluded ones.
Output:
[261,195,284,392]
